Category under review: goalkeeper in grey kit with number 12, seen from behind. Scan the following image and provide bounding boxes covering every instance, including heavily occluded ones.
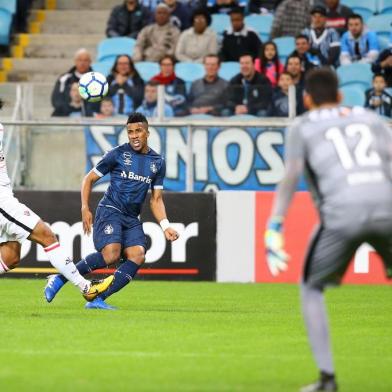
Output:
[265,68,392,392]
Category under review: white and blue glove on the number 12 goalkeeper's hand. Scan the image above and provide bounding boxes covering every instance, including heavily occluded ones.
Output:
[264,217,289,276]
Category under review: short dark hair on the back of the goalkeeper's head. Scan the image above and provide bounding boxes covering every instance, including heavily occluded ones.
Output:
[305,67,339,105]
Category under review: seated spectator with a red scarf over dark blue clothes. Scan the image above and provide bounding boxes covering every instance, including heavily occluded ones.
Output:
[151,56,188,116]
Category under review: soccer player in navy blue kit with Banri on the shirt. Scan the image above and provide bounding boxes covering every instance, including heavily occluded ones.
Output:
[44,112,179,309]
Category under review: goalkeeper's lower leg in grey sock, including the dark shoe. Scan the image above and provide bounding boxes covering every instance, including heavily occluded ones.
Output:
[301,283,337,392]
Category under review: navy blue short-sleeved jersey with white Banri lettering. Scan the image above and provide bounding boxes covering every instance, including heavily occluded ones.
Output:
[93,143,166,217]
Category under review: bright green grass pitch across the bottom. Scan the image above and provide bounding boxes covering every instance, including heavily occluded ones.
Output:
[0,279,392,392]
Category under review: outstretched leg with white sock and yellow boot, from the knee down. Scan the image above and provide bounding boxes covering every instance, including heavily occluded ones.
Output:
[28,221,113,301]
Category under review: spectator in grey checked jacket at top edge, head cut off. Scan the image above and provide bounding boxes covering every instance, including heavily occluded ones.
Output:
[271,0,310,39]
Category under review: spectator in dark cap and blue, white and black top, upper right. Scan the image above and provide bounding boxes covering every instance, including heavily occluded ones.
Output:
[302,6,340,67]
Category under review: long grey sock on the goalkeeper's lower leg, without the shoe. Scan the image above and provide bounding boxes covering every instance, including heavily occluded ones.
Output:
[301,283,335,375]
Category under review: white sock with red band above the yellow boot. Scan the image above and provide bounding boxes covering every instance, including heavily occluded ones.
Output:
[44,242,90,292]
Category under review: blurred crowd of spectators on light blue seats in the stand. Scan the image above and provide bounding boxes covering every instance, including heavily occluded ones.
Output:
[0,0,392,118]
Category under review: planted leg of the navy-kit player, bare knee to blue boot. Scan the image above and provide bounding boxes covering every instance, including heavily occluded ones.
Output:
[86,245,145,309]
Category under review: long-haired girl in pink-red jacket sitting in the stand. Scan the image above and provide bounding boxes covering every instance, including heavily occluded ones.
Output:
[255,41,284,87]
